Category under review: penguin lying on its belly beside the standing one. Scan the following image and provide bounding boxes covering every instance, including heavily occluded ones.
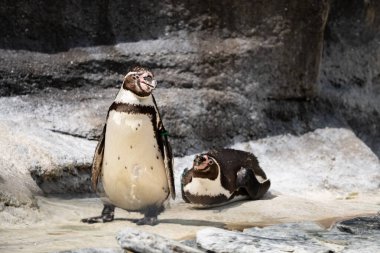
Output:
[181,149,270,206]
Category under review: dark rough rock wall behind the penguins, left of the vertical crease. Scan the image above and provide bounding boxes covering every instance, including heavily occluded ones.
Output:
[0,0,329,155]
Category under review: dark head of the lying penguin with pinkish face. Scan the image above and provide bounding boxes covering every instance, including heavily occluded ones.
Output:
[193,154,219,180]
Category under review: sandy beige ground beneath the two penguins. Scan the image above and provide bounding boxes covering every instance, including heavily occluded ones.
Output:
[0,192,380,253]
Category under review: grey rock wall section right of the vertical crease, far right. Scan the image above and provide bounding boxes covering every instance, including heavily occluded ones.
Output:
[319,0,380,156]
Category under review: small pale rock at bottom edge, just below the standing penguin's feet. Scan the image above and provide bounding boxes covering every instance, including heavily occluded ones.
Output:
[116,228,202,253]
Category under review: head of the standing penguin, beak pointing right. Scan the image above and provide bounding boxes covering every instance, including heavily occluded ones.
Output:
[123,67,157,97]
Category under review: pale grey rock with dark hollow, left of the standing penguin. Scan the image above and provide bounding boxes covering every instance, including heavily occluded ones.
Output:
[0,116,95,206]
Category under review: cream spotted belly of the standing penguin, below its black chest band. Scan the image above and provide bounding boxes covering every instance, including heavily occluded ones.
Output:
[102,111,169,211]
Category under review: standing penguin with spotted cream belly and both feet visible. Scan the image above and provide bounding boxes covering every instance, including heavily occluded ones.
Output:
[82,67,175,225]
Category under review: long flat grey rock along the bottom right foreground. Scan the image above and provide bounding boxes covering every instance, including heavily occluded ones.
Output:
[196,216,380,253]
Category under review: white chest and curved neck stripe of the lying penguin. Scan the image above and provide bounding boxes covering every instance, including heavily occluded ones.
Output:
[184,157,232,198]
